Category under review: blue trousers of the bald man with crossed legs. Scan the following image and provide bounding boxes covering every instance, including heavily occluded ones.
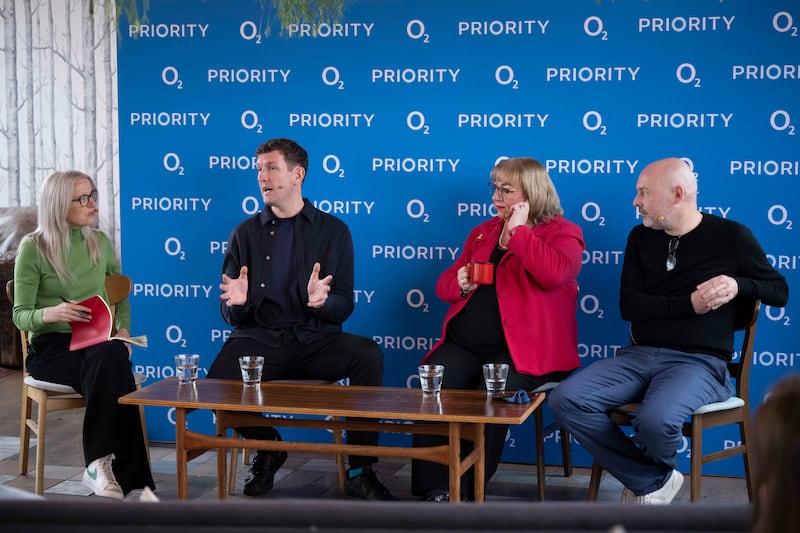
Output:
[549,345,734,496]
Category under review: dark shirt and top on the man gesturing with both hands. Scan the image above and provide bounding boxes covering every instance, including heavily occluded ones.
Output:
[220,200,354,345]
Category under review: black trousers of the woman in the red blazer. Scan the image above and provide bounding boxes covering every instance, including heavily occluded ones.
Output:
[411,341,570,498]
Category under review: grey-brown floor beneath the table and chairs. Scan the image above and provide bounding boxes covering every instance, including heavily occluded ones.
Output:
[0,372,747,503]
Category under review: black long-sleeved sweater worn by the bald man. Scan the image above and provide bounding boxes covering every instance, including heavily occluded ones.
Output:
[620,214,789,360]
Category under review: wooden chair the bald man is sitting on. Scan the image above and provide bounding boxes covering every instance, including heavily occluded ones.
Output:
[588,300,761,502]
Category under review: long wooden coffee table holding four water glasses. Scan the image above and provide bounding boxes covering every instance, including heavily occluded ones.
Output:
[119,378,545,503]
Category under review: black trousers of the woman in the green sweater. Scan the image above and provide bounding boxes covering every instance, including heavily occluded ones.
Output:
[26,333,155,493]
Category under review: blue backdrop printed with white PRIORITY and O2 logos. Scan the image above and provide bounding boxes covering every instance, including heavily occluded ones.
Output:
[118,0,800,475]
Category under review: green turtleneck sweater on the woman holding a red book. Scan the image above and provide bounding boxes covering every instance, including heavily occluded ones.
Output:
[13,229,131,339]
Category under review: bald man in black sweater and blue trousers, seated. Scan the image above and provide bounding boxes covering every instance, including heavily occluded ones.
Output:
[550,158,789,504]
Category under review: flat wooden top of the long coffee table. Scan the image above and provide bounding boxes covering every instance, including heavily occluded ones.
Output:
[119,378,544,424]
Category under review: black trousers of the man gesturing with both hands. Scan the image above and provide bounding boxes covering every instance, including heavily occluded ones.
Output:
[208,331,383,468]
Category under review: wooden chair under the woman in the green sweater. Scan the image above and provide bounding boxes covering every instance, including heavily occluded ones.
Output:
[6,274,150,495]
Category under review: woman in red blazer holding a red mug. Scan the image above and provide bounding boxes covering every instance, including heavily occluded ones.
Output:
[412,157,584,501]
